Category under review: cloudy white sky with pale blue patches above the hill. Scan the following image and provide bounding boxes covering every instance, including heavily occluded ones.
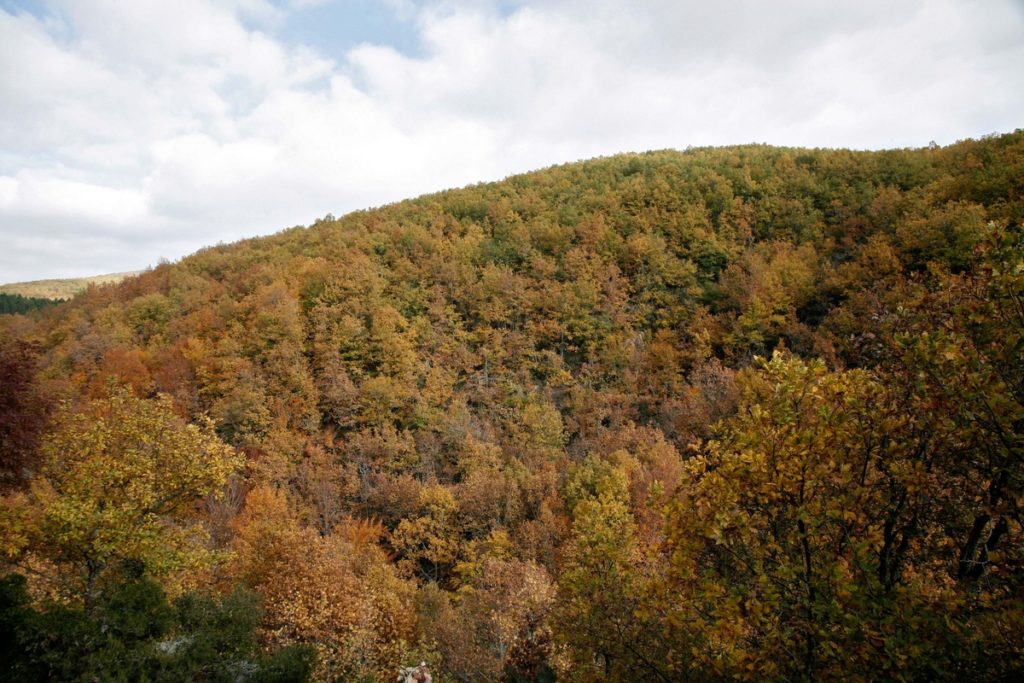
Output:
[0,0,1024,283]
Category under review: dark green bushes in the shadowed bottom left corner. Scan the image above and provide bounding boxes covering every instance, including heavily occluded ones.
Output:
[0,574,312,683]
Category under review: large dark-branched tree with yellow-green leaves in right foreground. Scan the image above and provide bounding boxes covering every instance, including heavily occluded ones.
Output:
[665,353,1020,681]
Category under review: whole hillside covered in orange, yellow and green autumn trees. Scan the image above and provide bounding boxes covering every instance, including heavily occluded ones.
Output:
[0,131,1024,681]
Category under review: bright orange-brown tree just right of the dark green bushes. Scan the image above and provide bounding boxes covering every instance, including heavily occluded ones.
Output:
[227,487,412,680]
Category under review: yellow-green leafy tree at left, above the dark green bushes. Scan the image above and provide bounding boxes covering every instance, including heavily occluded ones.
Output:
[0,387,242,608]
